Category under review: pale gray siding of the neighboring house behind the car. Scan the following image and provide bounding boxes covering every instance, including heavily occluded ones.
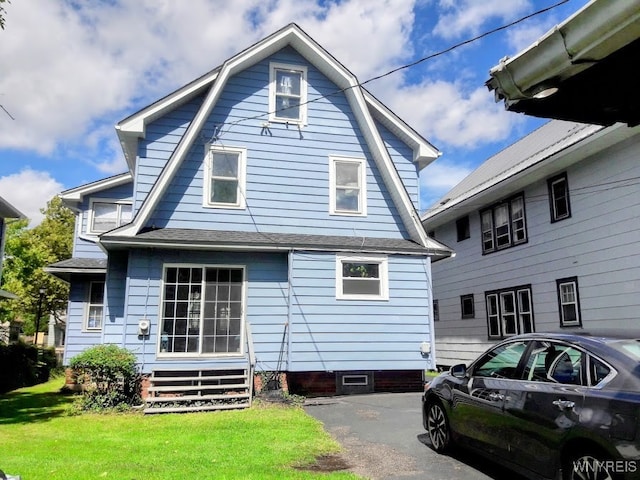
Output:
[432,130,640,365]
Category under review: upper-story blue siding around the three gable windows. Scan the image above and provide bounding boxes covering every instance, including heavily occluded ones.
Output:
[138,48,408,238]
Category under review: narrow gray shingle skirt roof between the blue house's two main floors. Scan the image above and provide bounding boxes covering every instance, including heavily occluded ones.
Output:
[101,228,450,255]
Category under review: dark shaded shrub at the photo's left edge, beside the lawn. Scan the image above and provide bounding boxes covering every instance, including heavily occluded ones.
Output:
[0,342,56,393]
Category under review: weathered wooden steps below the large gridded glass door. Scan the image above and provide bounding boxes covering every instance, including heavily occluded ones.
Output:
[144,366,253,414]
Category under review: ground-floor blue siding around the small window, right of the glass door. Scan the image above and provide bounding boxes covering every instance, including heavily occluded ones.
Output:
[288,252,435,371]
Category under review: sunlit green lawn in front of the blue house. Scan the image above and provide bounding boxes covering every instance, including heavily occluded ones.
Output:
[0,379,359,480]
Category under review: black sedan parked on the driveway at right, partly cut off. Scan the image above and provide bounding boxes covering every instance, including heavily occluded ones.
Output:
[422,331,640,480]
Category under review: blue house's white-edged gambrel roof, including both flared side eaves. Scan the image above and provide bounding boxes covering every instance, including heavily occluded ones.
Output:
[107,24,442,250]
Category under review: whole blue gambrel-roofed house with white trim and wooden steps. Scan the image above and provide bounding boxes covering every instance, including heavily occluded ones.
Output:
[49,24,451,411]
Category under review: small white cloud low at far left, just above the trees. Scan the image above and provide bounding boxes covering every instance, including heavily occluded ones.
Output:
[0,168,62,227]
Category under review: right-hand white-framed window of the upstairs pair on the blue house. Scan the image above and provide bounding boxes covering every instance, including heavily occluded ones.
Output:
[329,156,367,216]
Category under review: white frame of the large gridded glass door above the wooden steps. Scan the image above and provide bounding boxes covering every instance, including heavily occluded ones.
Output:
[156,263,247,358]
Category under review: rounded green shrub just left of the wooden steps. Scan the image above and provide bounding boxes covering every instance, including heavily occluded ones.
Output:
[69,345,140,410]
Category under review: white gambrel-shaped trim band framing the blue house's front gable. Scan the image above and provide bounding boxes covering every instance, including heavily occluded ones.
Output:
[110,24,441,248]
